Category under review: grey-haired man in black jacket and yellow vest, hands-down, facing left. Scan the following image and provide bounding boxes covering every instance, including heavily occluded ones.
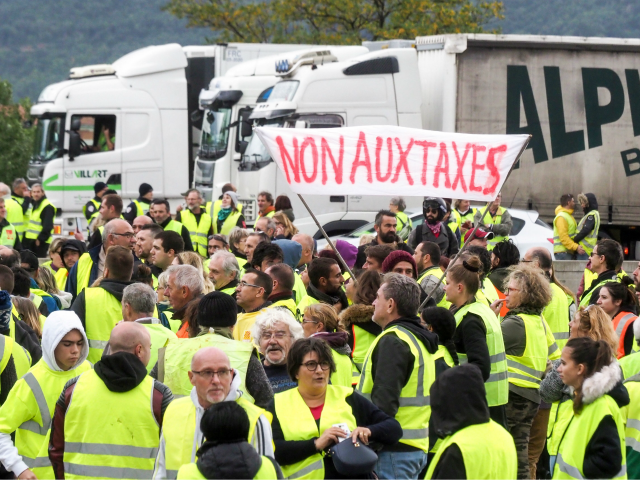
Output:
[357,273,438,479]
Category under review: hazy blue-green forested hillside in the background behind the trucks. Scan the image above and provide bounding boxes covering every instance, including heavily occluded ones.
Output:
[0,0,640,100]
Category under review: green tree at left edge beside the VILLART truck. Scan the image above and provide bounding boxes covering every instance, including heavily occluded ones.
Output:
[0,80,33,185]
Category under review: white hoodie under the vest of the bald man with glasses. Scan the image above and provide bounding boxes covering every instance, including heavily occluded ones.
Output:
[153,373,275,480]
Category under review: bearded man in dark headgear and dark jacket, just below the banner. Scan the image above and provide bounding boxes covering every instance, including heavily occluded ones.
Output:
[408,197,460,258]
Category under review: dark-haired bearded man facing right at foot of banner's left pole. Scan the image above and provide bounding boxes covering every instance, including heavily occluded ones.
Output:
[298,256,348,313]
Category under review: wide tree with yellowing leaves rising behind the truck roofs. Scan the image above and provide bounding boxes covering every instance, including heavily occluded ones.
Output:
[164,0,503,44]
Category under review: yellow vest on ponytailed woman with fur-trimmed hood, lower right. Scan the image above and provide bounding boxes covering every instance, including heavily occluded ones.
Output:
[553,395,627,480]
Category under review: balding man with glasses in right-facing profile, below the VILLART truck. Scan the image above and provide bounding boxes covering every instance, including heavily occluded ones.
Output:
[66,218,136,300]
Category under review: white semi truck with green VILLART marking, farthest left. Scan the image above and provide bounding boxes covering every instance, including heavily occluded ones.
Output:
[28,44,318,235]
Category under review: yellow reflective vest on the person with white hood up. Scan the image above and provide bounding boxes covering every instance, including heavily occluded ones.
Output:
[0,358,91,478]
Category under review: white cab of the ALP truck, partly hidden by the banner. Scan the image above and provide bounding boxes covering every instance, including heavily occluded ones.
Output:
[238,47,422,235]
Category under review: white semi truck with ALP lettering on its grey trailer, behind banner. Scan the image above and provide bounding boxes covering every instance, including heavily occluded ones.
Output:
[238,34,640,258]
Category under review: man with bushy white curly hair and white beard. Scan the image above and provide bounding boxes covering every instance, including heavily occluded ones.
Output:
[253,308,304,394]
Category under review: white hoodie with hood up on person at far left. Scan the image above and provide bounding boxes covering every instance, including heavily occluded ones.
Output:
[0,310,89,477]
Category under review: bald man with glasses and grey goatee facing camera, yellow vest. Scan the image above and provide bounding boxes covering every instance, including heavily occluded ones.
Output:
[153,347,274,480]
